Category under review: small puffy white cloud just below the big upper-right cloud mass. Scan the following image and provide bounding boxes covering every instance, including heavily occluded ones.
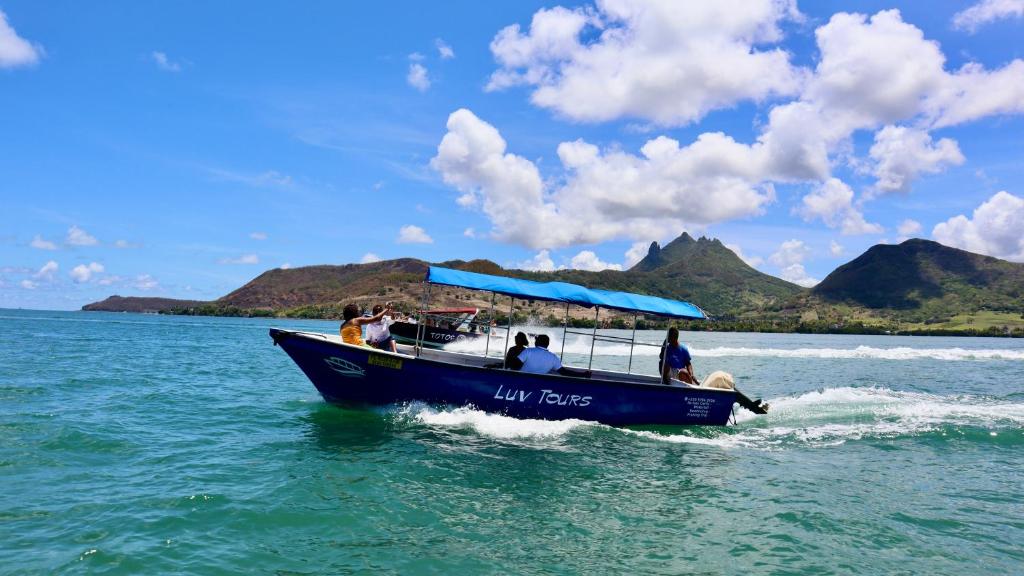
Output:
[869,125,964,193]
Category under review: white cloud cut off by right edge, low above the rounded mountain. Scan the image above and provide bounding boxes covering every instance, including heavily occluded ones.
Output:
[932,192,1024,262]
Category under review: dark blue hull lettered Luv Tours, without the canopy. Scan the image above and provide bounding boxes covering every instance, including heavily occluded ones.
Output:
[270,329,736,426]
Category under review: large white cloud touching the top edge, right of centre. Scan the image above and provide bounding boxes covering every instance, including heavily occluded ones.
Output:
[487,0,801,125]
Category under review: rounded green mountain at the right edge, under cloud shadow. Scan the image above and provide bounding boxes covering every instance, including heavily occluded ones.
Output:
[811,239,1024,316]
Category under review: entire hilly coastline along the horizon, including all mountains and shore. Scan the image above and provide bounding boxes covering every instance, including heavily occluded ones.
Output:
[82,233,1024,337]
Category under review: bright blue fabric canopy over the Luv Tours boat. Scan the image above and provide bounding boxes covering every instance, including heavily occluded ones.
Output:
[427,266,708,320]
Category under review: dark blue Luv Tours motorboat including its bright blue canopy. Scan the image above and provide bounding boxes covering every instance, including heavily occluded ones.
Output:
[270,266,767,426]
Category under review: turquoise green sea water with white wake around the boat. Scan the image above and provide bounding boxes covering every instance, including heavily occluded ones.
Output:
[0,311,1024,574]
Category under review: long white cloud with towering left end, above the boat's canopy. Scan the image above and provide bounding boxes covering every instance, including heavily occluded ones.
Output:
[431,109,774,248]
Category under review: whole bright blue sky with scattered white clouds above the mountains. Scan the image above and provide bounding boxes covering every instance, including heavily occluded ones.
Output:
[0,0,1024,310]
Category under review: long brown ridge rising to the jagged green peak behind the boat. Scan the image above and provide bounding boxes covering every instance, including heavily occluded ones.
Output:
[81,233,804,316]
